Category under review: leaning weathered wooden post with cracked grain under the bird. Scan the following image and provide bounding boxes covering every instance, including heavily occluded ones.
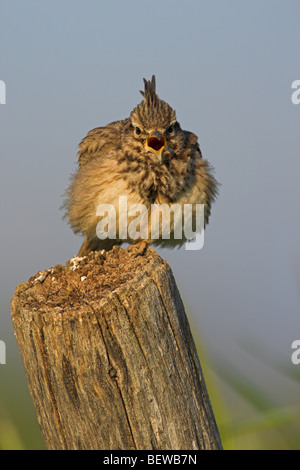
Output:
[11,244,221,450]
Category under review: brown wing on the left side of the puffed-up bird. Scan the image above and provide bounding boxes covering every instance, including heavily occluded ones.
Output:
[77,121,124,167]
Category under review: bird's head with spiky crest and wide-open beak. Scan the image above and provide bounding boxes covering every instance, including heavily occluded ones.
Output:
[129,75,182,163]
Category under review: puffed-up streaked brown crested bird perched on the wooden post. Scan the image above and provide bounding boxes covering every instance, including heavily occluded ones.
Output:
[65,76,218,256]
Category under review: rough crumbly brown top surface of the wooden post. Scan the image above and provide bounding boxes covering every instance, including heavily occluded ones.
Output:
[15,242,170,308]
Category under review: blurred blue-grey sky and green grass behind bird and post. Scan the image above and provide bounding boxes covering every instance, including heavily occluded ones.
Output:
[0,0,300,449]
